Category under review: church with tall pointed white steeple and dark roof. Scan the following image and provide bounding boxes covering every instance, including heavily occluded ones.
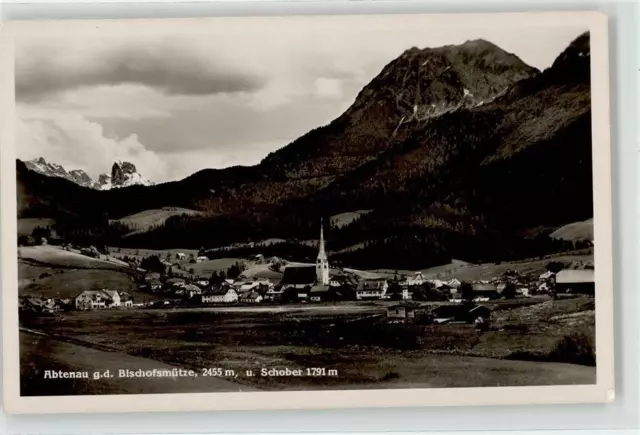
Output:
[280,220,329,301]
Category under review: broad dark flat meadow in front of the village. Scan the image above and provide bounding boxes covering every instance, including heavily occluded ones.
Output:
[20,298,595,390]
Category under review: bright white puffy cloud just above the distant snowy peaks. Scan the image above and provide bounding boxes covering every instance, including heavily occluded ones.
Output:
[16,114,168,181]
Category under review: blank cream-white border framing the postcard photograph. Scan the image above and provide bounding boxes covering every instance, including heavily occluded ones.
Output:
[0,11,615,414]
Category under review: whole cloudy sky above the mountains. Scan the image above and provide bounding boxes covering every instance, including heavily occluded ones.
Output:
[15,18,586,182]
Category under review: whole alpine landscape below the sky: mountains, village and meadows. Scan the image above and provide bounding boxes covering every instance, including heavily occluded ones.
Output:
[16,33,597,395]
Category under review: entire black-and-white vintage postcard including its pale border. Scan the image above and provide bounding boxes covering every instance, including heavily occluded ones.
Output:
[0,12,614,413]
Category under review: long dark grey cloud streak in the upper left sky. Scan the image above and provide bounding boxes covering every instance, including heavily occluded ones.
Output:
[16,45,265,101]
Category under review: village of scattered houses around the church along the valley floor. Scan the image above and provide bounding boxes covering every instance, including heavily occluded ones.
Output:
[20,221,595,325]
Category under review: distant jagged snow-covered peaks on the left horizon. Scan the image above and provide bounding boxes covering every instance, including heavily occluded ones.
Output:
[25,157,153,190]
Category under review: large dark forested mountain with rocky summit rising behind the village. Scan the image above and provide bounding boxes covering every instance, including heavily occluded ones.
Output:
[18,33,593,268]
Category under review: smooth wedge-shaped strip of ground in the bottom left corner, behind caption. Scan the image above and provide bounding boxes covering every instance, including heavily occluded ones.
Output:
[20,332,257,395]
